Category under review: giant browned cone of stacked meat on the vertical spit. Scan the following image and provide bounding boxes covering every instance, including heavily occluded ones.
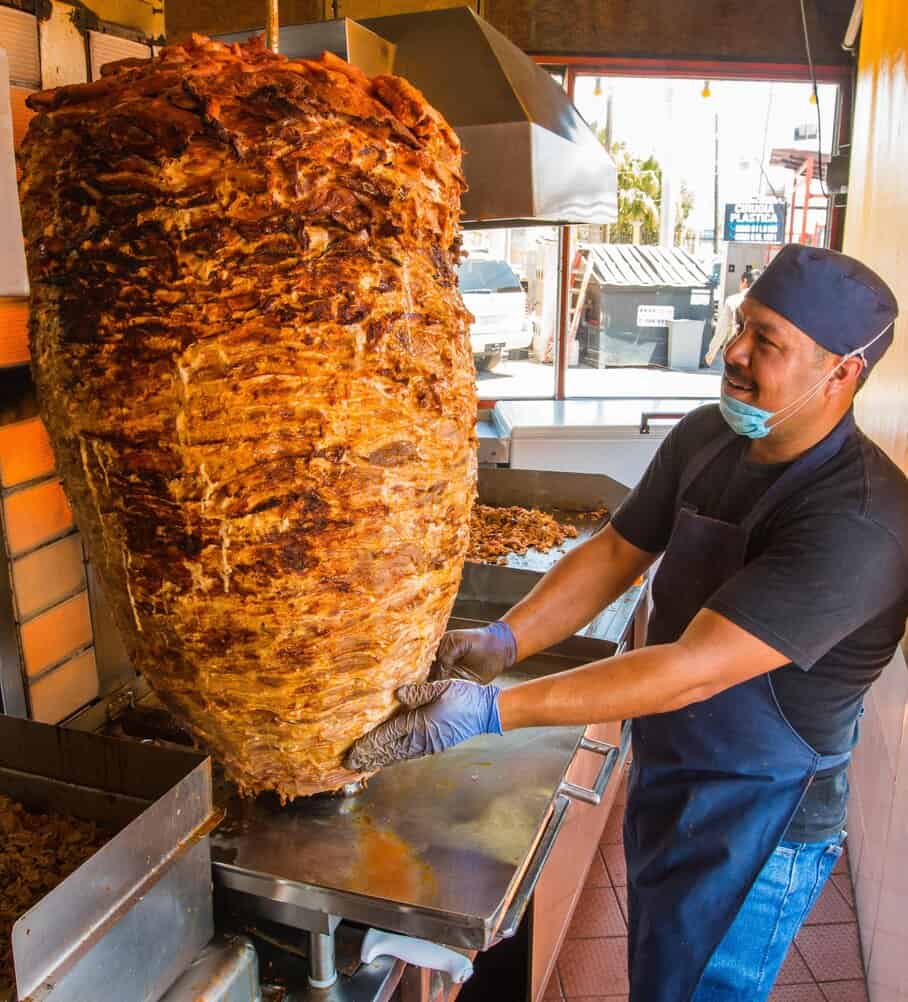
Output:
[21,36,476,800]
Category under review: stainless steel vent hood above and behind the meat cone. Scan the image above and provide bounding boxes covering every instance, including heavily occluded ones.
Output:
[218,7,617,226]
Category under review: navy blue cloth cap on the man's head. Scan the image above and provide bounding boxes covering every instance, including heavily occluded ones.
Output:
[748,243,899,370]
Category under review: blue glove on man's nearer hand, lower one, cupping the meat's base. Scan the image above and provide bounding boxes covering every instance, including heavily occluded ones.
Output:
[344,678,501,773]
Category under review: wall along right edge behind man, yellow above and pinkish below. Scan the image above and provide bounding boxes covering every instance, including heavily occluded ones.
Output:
[845,0,908,1002]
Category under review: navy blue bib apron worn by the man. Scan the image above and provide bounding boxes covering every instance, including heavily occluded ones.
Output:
[624,412,855,1002]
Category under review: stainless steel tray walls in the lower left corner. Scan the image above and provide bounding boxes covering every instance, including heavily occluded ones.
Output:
[0,716,218,1002]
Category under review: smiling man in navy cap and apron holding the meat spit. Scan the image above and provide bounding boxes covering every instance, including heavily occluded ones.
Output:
[348,244,908,1002]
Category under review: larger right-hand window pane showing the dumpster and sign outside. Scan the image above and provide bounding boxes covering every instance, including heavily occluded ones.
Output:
[566,75,837,397]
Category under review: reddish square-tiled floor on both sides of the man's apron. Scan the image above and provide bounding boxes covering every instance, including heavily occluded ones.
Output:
[545,765,867,1002]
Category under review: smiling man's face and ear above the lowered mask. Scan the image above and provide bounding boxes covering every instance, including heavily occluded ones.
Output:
[723,296,860,422]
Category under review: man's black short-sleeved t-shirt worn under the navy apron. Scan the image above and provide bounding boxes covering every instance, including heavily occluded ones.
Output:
[612,405,908,842]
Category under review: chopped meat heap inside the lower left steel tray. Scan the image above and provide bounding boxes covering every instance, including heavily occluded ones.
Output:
[0,794,110,991]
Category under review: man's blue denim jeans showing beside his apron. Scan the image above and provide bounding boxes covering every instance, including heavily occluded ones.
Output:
[691,832,845,1002]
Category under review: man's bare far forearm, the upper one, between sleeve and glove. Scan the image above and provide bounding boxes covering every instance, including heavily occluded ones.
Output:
[504,526,655,660]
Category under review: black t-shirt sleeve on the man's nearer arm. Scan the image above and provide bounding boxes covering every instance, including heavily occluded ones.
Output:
[706,514,908,670]
